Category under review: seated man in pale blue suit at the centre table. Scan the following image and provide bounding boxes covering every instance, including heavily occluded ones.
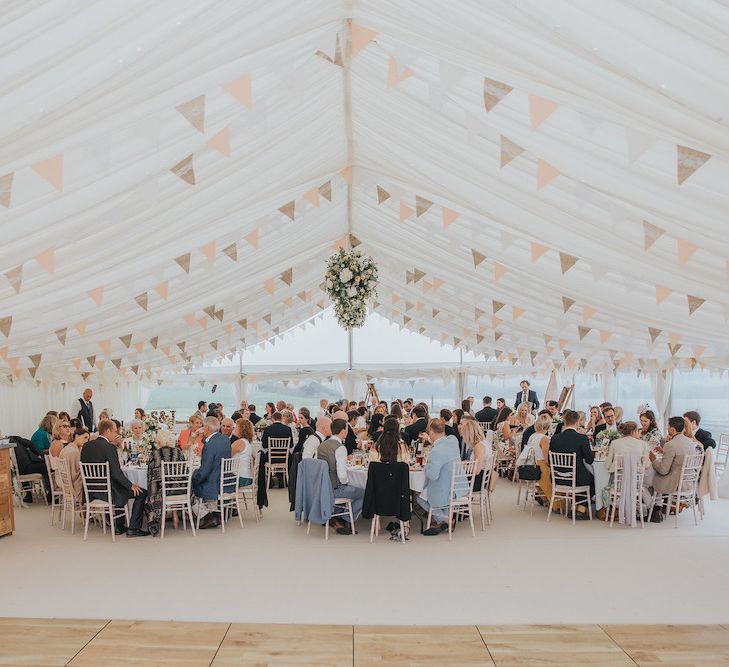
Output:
[417,419,461,535]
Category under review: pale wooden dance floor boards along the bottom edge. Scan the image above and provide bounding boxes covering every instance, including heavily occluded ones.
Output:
[0,618,729,667]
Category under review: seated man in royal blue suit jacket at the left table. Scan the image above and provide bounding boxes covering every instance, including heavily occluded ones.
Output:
[192,415,230,528]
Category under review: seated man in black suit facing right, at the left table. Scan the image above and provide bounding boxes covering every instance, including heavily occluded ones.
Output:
[81,420,149,537]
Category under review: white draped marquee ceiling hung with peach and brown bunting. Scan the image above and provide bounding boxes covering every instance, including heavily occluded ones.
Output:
[0,0,729,428]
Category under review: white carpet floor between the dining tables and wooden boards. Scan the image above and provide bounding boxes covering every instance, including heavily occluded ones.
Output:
[0,480,729,625]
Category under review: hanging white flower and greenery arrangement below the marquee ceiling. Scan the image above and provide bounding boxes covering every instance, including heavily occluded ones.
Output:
[324,249,379,329]
